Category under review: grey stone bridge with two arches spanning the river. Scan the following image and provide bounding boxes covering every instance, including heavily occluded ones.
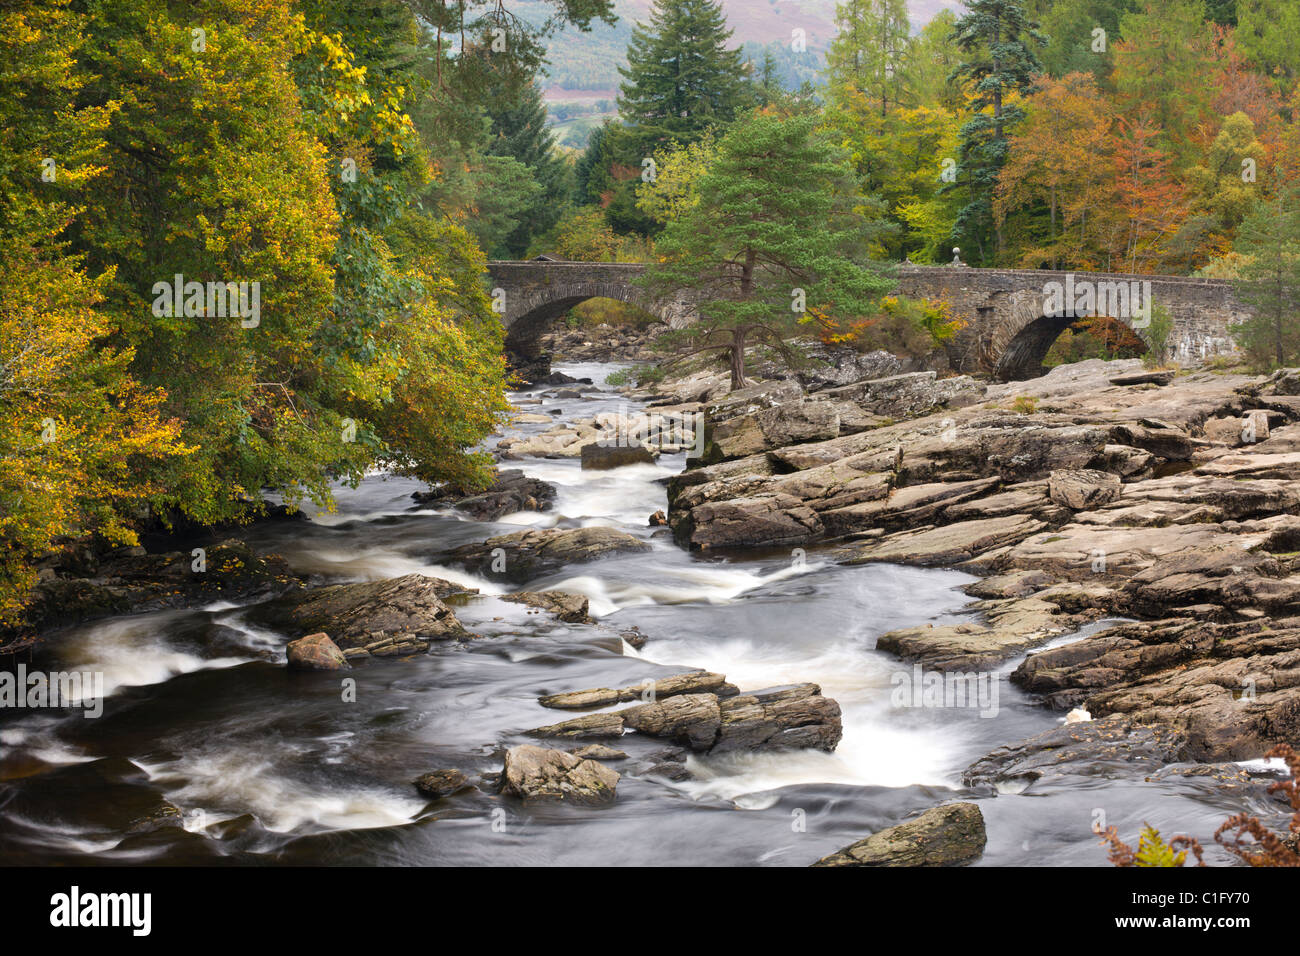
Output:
[488,260,1249,380]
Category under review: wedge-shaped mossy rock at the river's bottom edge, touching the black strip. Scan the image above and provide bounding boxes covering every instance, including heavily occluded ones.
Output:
[813,803,988,866]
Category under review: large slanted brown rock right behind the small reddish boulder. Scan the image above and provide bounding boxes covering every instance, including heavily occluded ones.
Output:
[250,575,473,657]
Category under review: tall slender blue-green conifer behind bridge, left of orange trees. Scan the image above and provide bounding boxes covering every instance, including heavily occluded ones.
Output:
[950,0,1043,264]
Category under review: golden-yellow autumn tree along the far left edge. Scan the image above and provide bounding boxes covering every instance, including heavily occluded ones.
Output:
[0,0,191,630]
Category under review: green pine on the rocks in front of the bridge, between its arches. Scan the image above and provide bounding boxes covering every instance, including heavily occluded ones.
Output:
[645,113,892,389]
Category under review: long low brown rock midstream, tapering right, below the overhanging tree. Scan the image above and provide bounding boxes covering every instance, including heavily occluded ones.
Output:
[449,527,650,584]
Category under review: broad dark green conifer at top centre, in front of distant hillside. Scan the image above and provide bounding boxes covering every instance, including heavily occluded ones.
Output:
[619,0,749,157]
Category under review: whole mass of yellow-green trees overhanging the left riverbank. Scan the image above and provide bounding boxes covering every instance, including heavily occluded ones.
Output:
[0,0,626,623]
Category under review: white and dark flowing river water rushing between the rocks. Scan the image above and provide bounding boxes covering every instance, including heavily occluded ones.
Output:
[0,365,1279,865]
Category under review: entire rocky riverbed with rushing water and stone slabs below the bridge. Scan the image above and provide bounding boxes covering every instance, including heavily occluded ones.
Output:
[0,358,1300,865]
